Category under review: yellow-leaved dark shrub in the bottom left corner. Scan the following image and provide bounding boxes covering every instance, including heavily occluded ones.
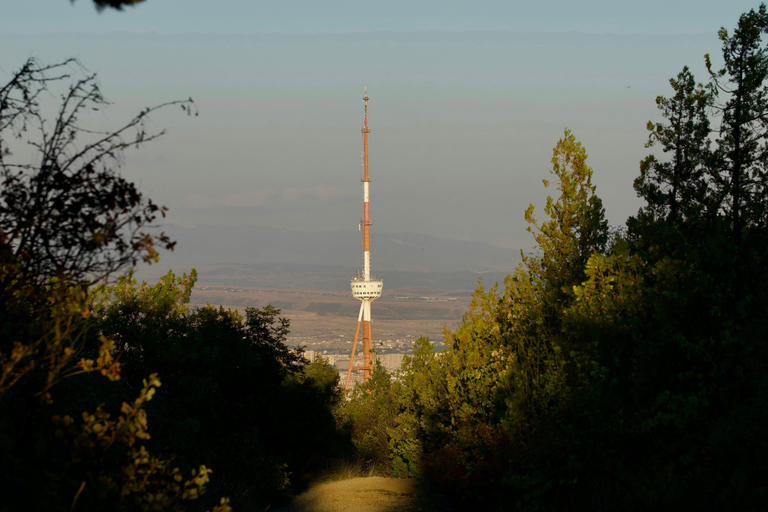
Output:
[0,276,229,511]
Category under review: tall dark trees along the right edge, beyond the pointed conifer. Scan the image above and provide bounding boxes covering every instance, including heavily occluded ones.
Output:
[567,6,768,509]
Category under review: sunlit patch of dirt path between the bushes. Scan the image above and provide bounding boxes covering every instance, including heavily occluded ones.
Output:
[286,476,420,512]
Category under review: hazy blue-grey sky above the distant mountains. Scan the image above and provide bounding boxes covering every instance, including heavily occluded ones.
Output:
[0,0,758,272]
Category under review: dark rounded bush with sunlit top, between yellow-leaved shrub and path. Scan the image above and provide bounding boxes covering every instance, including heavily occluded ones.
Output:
[92,271,347,507]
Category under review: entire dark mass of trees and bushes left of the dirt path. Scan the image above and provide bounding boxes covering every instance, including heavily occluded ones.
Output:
[0,60,349,512]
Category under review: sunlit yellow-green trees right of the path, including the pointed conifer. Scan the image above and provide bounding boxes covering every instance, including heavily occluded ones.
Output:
[391,130,608,508]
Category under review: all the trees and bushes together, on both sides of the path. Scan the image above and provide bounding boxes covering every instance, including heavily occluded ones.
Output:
[0,6,768,512]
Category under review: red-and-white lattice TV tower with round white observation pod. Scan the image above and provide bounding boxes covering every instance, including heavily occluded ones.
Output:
[344,87,384,390]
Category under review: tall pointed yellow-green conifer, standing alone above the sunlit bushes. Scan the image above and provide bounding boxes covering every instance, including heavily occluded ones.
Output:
[499,129,608,425]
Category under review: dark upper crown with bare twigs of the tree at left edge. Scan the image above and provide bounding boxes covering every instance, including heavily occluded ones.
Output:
[0,59,193,287]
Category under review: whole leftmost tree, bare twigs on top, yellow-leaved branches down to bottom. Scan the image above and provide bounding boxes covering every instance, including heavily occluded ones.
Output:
[0,60,230,512]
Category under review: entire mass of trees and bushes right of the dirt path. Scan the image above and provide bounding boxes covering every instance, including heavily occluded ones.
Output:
[348,10,768,502]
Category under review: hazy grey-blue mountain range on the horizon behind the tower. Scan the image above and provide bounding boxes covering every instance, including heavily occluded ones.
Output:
[137,225,520,290]
